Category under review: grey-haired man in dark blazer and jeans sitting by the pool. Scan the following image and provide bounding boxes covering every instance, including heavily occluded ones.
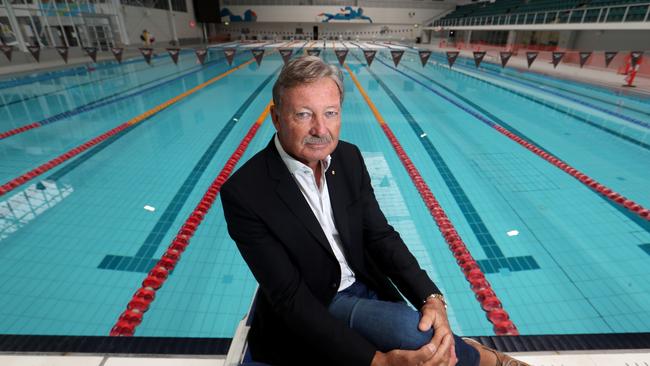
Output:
[221,56,524,366]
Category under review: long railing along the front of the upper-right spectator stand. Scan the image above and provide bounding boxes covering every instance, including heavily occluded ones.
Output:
[433,3,650,27]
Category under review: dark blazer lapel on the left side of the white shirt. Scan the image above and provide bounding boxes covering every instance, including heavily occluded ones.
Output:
[266,139,334,256]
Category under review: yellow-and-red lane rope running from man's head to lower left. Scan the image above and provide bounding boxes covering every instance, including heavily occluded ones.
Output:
[110,103,271,336]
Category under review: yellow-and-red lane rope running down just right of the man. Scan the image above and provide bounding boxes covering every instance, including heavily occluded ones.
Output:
[345,65,519,335]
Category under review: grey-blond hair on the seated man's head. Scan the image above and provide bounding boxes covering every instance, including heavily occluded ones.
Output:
[273,56,343,107]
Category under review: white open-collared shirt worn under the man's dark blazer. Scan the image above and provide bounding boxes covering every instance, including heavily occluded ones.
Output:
[274,134,354,291]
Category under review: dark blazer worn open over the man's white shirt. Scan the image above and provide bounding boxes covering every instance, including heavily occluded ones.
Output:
[221,139,439,365]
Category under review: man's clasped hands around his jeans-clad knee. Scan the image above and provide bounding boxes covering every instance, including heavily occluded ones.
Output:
[371,298,458,366]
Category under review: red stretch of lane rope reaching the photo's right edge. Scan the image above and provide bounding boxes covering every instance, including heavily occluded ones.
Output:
[493,125,650,221]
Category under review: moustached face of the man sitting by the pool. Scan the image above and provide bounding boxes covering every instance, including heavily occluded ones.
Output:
[271,78,341,169]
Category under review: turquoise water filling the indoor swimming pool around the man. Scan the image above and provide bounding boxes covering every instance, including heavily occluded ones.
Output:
[0,43,650,338]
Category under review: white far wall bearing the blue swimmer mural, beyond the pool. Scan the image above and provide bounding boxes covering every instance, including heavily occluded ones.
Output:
[222,2,454,24]
